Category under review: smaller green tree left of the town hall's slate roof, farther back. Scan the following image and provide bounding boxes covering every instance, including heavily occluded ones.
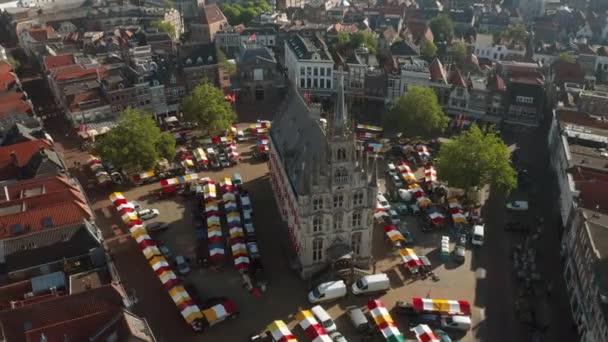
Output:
[182,81,236,134]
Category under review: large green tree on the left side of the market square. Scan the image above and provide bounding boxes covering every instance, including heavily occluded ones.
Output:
[95,108,175,173]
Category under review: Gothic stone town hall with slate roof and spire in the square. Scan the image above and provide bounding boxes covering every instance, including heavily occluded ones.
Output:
[269,79,377,278]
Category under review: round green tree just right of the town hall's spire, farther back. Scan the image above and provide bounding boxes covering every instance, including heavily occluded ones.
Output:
[386,86,448,137]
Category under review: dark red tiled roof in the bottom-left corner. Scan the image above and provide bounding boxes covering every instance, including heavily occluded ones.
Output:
[0,285,122,341]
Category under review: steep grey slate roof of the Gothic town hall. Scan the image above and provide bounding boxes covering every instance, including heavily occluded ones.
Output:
[270,87,328,195]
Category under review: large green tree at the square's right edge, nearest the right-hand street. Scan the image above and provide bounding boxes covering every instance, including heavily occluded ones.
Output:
[437,125,517,193]
